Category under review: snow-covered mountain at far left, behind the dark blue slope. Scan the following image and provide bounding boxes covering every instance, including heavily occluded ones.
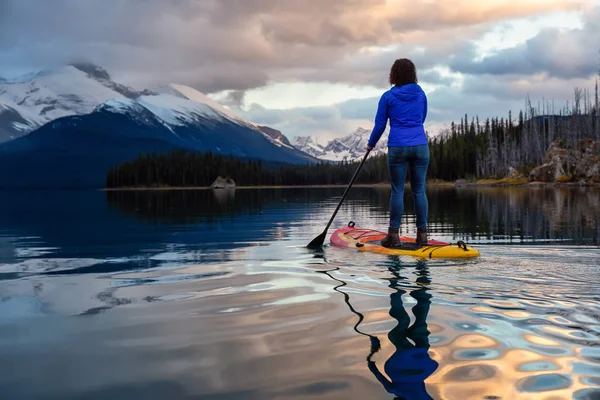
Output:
[0,63,151,143]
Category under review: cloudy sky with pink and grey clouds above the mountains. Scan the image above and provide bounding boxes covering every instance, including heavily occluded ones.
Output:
[0,0,600,142]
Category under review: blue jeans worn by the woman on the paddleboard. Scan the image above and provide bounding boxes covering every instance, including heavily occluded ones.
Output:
[388,144,429,229]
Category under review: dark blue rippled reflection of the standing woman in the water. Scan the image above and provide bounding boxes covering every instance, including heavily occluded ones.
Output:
[367,265,438,400]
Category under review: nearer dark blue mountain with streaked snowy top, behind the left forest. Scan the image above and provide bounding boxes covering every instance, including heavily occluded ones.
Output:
[0,94,316,188]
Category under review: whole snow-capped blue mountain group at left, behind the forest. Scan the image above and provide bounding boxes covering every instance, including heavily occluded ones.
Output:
[0,64,318,188]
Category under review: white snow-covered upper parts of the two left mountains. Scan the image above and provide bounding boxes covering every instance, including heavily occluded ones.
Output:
[0,63,296,150]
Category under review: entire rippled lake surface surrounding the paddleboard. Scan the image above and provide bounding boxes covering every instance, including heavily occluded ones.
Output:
[0,187,600,400]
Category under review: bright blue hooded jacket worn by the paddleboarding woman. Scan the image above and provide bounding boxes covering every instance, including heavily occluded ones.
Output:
[368,83,427,147]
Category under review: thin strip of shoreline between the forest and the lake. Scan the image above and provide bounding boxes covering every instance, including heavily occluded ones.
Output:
[98,179,600,192]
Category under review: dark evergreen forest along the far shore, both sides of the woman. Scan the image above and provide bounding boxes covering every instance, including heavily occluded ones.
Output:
[106,82,600,188]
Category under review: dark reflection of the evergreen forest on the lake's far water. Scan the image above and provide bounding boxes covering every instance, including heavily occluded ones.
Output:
[106,186,600,244]
